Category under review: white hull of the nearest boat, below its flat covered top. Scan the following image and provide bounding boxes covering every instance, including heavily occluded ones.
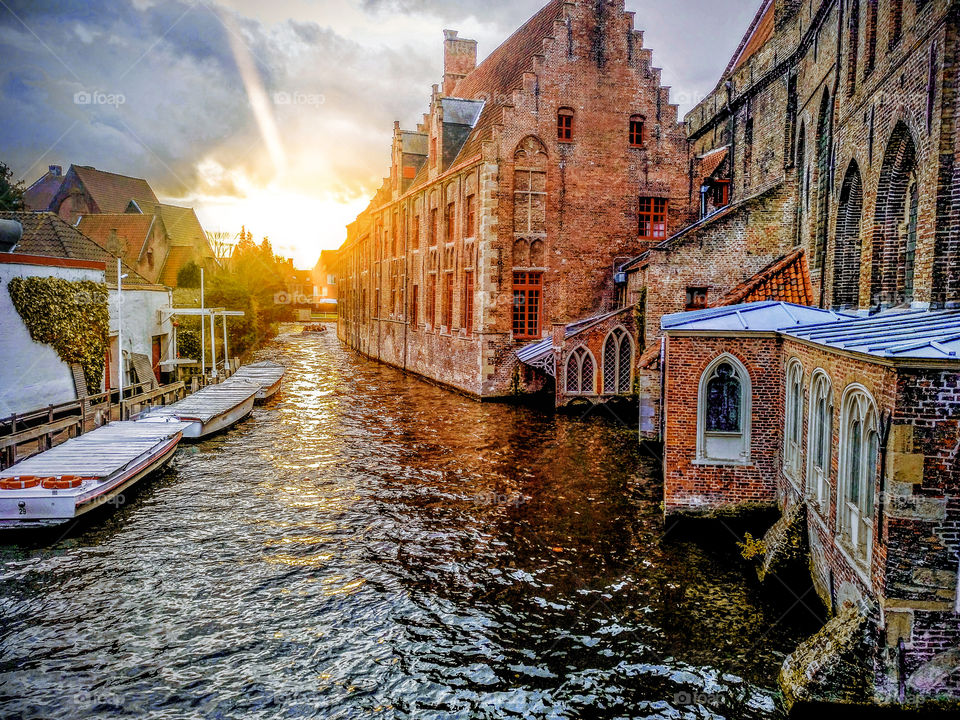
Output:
[0,433,181,531]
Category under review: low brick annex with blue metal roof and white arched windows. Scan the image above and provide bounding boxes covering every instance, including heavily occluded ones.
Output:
[663,302,960,702]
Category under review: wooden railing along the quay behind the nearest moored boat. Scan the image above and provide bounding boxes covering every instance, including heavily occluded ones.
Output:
[0,382,186,468]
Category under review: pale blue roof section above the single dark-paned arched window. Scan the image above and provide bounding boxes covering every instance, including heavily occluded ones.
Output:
[660,301,854,332]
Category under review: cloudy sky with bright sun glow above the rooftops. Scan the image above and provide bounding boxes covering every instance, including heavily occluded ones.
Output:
[0,0,759,268]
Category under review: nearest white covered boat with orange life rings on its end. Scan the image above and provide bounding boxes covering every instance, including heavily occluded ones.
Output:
[0,421,186,530]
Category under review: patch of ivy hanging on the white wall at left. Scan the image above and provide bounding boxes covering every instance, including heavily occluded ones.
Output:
[7,277,110,393]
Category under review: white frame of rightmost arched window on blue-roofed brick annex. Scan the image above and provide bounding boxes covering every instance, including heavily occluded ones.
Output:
[836,383,880,574]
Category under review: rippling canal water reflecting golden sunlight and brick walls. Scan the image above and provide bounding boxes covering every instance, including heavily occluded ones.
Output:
[0,332,818,719]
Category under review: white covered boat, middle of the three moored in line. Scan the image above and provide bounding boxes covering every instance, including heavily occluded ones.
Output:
[137,378,261,440]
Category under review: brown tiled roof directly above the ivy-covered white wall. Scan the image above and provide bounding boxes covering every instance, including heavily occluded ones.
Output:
[0,212,150,285]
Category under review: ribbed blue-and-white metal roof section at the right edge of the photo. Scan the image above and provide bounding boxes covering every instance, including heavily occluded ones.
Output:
[783,310,960,360]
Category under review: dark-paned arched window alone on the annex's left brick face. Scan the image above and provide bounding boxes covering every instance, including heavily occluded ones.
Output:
[697,354,752,464]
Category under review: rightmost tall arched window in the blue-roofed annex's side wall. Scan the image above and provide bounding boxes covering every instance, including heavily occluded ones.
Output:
[837,385,880,568]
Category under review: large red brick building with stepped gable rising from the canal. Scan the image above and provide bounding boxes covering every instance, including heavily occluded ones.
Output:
[337,0,693,397]
